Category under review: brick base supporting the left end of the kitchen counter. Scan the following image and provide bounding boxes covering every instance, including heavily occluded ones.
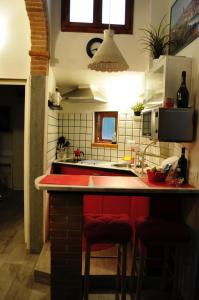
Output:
[50,192,83,300]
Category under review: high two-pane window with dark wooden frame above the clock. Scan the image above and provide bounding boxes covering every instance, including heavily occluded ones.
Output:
[61,0,133,34]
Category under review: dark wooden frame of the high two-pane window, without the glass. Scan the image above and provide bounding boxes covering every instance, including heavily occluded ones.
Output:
[61,0,134,34]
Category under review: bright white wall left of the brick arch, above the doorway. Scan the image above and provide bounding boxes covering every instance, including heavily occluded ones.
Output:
[0,0,30,78]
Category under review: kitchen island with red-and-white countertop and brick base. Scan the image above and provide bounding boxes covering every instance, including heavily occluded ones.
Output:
[35,174,199,300]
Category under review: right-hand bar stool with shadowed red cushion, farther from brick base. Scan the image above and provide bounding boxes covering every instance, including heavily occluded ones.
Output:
[132,217,190,300]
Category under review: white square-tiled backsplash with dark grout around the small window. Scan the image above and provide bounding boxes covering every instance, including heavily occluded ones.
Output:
[57,112,181,166]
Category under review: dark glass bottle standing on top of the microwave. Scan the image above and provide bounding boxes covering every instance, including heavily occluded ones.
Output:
[176,71,189,108]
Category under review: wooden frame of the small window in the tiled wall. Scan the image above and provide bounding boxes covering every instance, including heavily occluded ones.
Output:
[95,111,118,144]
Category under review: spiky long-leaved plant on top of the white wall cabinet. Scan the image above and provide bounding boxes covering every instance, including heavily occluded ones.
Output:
[140,16,170,59]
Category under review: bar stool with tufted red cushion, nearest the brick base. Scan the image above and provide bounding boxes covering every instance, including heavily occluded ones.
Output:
[84,214,132,300]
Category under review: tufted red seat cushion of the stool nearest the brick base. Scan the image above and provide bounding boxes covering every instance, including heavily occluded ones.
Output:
[84,214,132,244]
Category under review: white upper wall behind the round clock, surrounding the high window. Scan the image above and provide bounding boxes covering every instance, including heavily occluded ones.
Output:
[51,0,149,87]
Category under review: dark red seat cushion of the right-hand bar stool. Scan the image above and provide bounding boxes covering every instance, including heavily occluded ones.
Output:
[135,217,190,243]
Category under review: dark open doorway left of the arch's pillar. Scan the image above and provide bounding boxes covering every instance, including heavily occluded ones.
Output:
[0,84,25,223]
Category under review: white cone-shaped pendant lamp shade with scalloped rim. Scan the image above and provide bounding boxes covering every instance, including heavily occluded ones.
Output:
[88,29,129,72]
